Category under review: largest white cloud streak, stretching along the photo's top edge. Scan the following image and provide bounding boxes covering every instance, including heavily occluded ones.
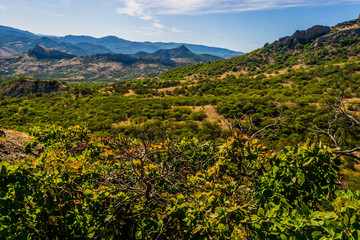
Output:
[117,0,360,20]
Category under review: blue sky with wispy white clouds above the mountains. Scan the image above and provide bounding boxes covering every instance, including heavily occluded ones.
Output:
[0,0,360,52]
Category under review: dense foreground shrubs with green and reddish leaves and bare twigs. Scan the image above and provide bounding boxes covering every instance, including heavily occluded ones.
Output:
[0,126,360,239]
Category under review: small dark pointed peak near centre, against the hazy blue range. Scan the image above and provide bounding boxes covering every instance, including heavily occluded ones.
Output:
[133,45,223,63]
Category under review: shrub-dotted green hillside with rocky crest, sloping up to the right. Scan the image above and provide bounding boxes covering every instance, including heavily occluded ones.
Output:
[160,19,360,78]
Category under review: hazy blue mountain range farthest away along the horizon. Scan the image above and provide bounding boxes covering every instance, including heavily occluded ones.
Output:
[0,26,243,58]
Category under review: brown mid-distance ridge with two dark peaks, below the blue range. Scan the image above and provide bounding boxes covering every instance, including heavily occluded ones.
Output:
[0,45,218,82]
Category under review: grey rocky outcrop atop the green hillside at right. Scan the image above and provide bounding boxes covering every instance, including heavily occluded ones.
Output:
[278,25,331,47]
